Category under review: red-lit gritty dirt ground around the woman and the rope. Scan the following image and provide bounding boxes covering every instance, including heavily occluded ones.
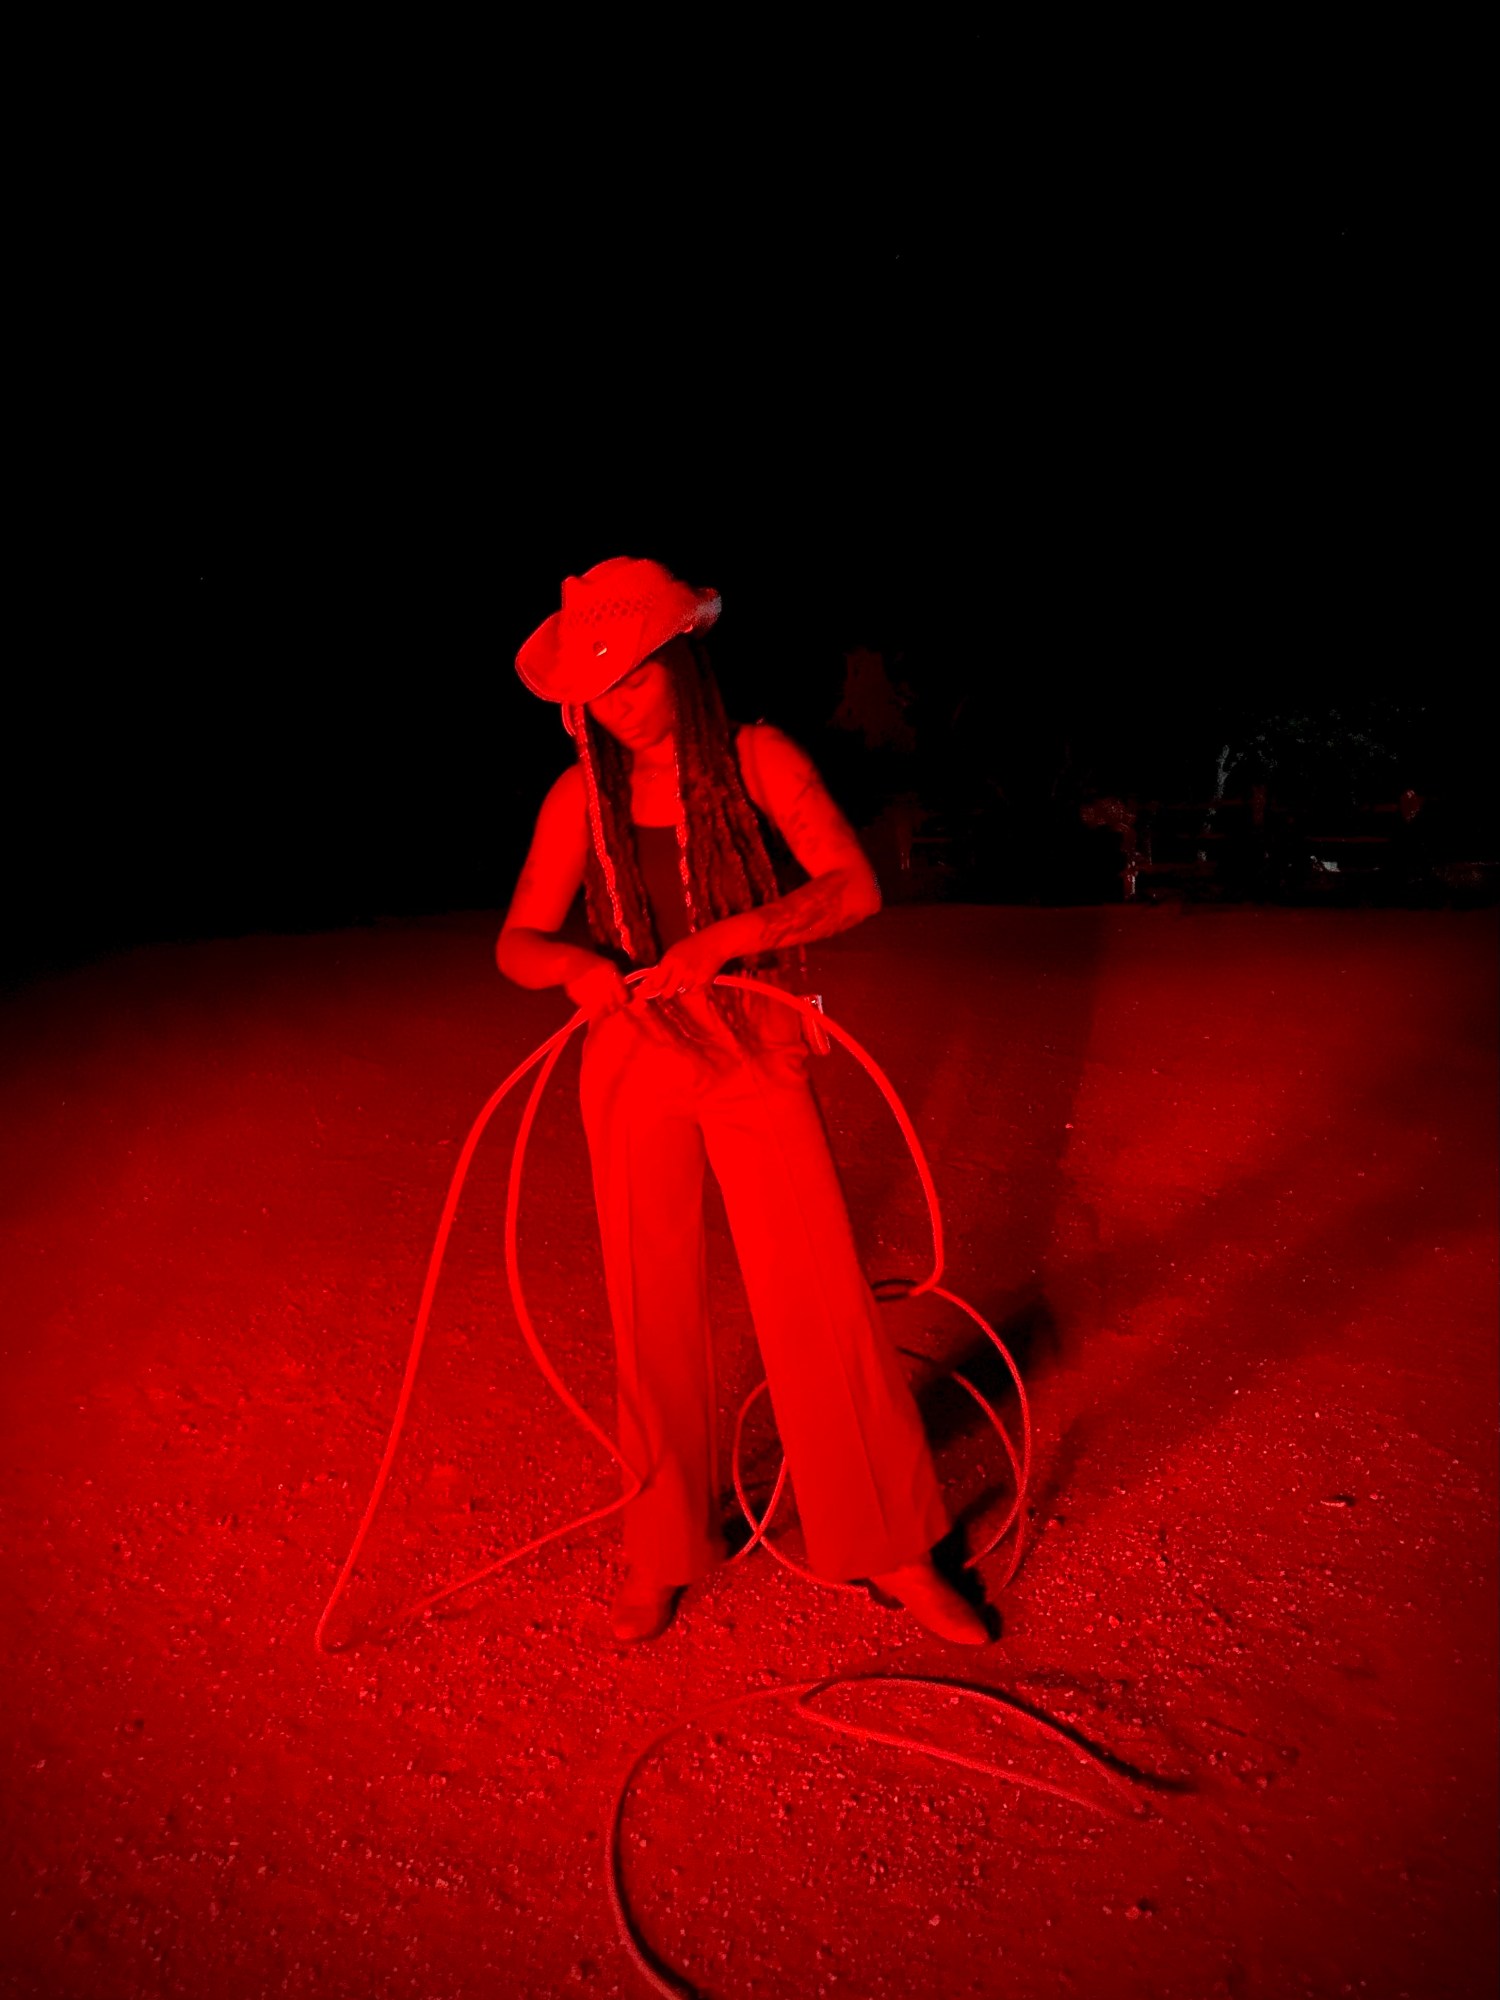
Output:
[0,906,1496,2000]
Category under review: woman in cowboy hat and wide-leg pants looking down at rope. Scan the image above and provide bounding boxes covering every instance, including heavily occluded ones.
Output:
[496,558,988,1644]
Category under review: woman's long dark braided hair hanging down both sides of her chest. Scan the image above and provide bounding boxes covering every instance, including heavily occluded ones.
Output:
[564,638,806,1050]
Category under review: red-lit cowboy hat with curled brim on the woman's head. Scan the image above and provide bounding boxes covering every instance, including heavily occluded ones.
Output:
[516,556,722,702]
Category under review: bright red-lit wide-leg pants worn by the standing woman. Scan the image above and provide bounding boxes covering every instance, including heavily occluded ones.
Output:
[580,996,950,1586]
